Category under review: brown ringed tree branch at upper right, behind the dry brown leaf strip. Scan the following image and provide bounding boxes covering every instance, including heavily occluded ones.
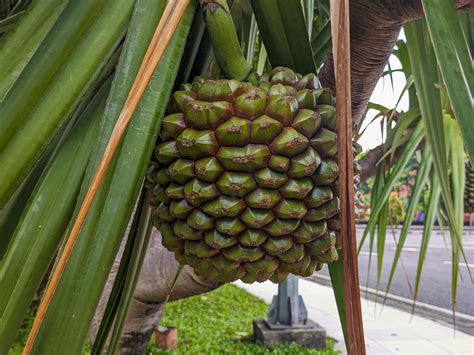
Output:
[320,0,474,124]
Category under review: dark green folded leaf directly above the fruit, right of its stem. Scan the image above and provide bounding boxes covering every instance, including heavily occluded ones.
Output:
[251,0,316,74]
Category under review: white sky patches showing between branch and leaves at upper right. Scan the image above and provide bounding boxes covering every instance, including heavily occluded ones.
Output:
[358,32,408,151]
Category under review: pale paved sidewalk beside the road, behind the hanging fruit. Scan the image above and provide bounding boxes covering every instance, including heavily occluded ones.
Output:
[235,279,474,355]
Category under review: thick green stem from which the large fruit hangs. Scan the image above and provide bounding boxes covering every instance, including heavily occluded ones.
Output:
[200,0,253,81]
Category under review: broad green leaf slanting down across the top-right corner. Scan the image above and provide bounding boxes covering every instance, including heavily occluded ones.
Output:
[422,0,474,162]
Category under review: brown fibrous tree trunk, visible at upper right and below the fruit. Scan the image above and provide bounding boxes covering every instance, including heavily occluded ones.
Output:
[90,0,474,354]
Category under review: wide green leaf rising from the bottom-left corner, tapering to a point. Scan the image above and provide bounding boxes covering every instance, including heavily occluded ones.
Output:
[0,80,110,354]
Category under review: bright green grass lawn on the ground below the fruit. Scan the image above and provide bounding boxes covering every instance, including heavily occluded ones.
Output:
[148,285,337,355]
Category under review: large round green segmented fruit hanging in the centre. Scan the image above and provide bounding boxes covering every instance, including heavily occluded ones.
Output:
[149,67,340,283]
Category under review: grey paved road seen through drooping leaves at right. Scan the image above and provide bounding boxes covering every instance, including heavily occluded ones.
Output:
[322,226,474,315]
